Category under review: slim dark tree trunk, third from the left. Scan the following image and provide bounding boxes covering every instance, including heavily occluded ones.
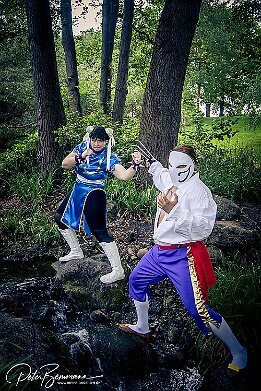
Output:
[100,0,119,114]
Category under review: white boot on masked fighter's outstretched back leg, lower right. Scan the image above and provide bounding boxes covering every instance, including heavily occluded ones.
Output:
[209,318,247,372]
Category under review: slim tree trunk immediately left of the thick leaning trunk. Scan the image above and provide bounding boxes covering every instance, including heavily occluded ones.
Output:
[112,0,134,124]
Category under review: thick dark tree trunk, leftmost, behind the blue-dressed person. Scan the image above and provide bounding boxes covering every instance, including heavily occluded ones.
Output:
[26,0,66,175]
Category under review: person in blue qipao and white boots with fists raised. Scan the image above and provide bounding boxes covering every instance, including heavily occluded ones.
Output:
[55,126,141,284]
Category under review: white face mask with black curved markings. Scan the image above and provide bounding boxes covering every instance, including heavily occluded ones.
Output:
[169,151,194,187]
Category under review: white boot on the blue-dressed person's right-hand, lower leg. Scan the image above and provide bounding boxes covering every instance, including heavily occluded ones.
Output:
[100,242,125,284]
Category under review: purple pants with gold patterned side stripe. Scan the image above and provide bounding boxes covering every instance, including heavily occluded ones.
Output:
[129,245,222,335]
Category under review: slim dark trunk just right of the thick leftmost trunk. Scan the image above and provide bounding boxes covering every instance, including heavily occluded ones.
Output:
[61,0,82,113]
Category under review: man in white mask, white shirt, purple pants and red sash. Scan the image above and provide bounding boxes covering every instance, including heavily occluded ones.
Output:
[119,145,247,377]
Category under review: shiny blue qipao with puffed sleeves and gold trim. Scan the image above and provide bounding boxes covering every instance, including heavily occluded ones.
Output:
[61,142,121,236]
